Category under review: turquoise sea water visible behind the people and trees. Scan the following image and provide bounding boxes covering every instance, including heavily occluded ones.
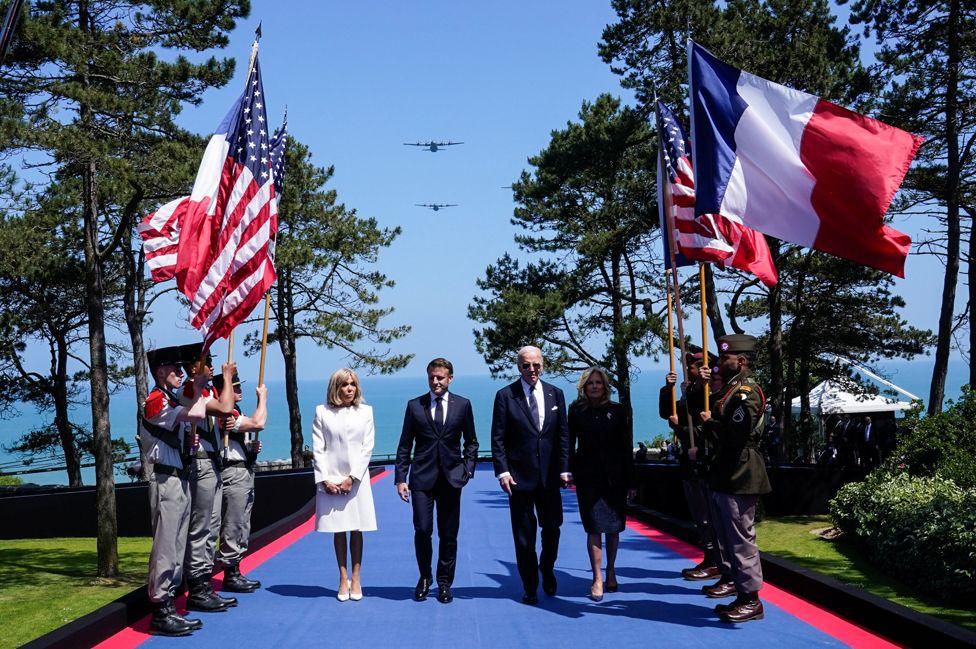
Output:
[0,359,968,484]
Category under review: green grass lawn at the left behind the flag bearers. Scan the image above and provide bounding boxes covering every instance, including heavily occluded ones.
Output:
[0,537,152,647]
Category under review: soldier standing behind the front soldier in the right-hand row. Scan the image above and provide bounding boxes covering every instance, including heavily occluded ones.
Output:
[658,351,719,581]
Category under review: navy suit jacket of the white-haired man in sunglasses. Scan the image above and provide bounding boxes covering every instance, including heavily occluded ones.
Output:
[491,380,569,491]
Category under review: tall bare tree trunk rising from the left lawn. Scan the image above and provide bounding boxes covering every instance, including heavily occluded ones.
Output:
[82,161,119,577]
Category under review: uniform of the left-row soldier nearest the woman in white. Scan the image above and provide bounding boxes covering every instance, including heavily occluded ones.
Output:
[214,375,261,593]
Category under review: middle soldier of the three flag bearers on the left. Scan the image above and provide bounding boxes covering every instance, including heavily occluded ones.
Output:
[180,343,237,613]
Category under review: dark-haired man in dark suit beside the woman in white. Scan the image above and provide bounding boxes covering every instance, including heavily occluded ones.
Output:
[395,358,478,604]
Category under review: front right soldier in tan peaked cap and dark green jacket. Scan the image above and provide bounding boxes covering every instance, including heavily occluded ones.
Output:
[701,334,771,622]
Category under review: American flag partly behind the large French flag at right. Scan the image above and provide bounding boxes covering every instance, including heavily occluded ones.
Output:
[657,101,778,286]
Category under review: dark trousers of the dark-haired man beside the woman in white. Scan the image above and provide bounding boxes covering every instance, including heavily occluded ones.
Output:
[410,476,461,586]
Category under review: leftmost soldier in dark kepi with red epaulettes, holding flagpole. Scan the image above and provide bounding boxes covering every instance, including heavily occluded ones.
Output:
[139,347,209,636]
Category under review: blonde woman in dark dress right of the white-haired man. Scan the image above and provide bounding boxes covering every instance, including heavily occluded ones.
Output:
[569,367,636,602]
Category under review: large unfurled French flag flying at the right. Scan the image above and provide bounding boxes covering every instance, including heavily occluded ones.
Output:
[688,41,922,277]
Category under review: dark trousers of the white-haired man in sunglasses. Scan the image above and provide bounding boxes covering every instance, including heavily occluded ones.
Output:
[508,484,563,593]
